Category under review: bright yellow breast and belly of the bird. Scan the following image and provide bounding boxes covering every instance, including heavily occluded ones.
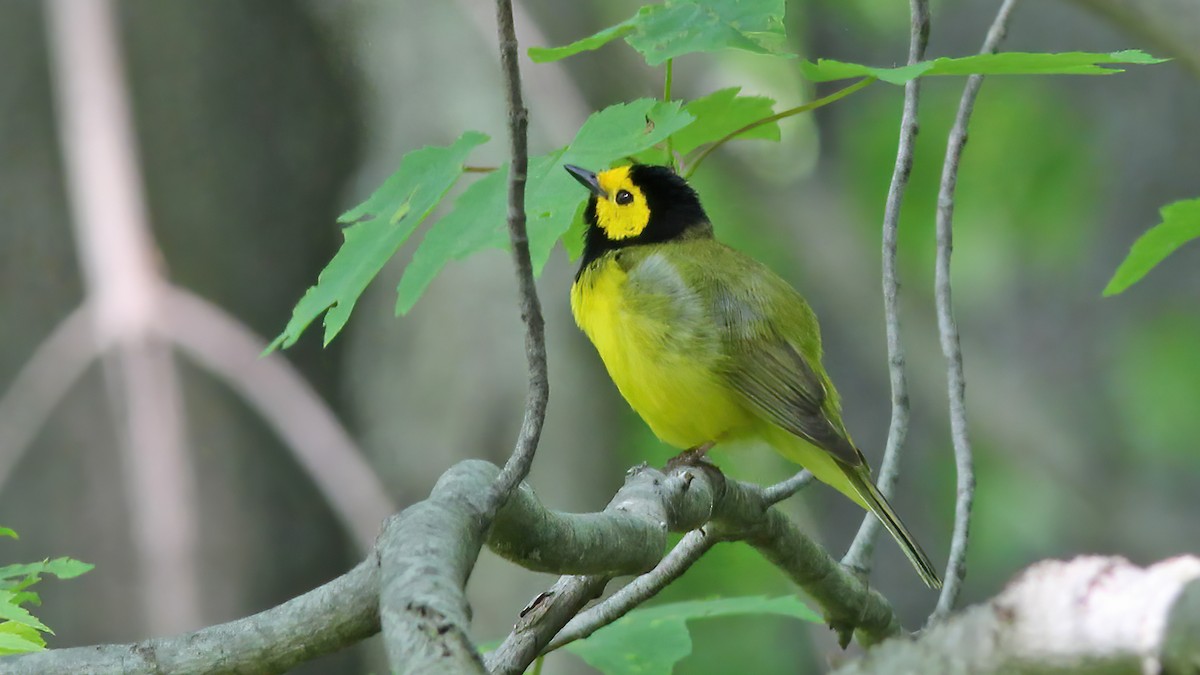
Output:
[571,253,755,448]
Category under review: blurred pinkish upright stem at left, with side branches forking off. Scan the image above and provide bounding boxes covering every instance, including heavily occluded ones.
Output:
[46,0,200,631]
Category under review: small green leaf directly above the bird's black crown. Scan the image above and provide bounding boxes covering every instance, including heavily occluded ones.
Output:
[671,86,779,154]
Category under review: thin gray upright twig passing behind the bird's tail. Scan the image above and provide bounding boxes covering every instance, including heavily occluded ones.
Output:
[842,0,929,577]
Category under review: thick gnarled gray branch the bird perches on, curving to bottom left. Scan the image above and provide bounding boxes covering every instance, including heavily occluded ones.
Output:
[0,460,899,674]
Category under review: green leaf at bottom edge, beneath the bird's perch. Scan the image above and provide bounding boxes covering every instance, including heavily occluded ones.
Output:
[564,596,822,675]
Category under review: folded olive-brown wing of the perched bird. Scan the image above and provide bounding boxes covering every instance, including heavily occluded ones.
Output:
[707,243,865,467]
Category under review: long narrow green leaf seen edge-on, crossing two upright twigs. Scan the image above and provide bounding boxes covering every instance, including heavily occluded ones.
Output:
[800,49,1169,84]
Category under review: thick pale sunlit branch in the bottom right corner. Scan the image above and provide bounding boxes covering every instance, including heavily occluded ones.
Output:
[836,556,1200,675]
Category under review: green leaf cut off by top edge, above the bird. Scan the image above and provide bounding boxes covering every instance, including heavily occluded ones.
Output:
[529,0,791,66]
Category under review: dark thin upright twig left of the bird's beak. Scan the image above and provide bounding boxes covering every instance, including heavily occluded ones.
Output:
[487,0,550,513]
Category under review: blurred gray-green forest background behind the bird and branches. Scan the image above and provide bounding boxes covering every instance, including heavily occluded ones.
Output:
[0,0,1200,674]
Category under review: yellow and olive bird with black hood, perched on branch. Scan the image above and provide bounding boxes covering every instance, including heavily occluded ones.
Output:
[565,159,942,589]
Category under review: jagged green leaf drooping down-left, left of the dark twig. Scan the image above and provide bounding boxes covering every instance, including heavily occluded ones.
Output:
[268,131,487,351]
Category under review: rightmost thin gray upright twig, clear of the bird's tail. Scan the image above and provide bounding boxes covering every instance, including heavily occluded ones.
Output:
[929,0,1016,622]
